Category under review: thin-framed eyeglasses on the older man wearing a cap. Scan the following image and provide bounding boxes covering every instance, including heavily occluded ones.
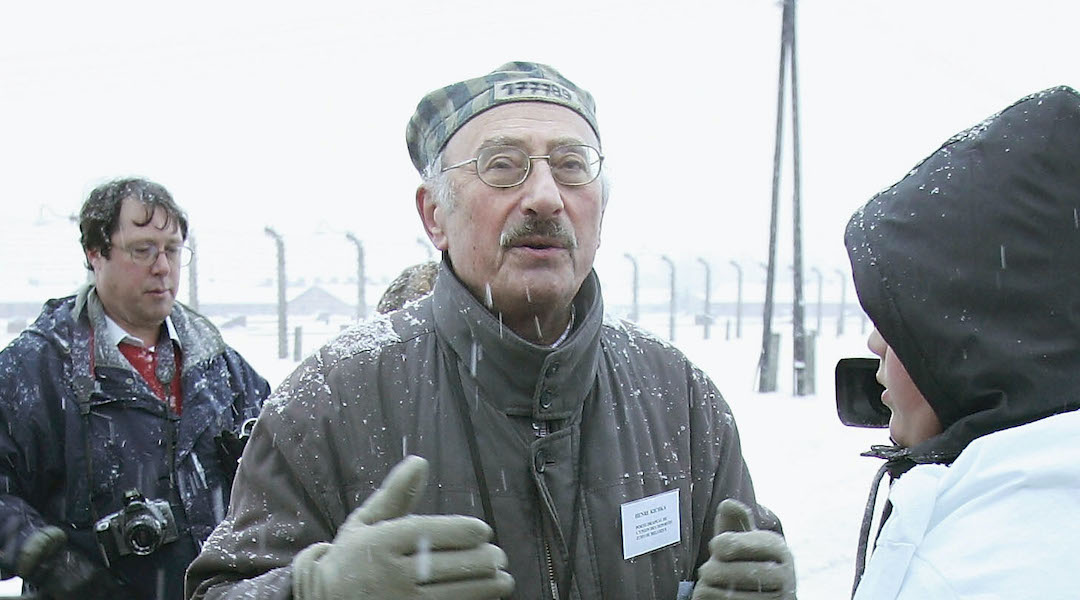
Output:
[442,144,604,188]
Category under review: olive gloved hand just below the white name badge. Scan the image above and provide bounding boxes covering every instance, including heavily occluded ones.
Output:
[693,499,795,600]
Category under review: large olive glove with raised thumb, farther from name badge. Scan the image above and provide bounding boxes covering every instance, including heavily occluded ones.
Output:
[293,456,514,600]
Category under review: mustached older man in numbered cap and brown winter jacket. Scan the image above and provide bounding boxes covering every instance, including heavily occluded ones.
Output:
[188,63,794,600]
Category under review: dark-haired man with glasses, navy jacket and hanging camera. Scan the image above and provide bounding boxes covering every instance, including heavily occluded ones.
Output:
[0,179,270,600]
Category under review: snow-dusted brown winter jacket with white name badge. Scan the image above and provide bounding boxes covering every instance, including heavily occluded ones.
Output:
[187,263,780,600]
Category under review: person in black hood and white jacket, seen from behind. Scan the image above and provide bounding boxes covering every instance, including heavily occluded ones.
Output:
[845,86,1080,600]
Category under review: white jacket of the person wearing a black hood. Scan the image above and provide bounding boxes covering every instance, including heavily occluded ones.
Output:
[854,411,1080,600]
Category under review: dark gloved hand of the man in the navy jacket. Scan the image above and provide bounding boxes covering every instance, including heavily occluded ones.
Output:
[16,526,131,600]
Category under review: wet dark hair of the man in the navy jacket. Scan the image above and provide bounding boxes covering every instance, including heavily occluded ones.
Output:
[79,177,188,269]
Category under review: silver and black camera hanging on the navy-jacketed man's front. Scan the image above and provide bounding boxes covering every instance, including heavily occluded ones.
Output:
[94,489,179,563]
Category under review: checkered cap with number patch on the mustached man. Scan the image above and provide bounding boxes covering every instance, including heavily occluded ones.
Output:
[405,62,600,174]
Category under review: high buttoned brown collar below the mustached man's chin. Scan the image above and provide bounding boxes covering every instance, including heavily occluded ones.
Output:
[432,260,604,421]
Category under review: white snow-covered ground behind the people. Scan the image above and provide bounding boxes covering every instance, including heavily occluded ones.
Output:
[0,306,887,600]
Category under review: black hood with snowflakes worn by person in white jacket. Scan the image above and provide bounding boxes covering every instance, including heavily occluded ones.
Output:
[845,86,1080,463]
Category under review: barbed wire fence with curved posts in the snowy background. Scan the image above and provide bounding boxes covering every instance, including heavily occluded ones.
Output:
[0,210,866,388]
